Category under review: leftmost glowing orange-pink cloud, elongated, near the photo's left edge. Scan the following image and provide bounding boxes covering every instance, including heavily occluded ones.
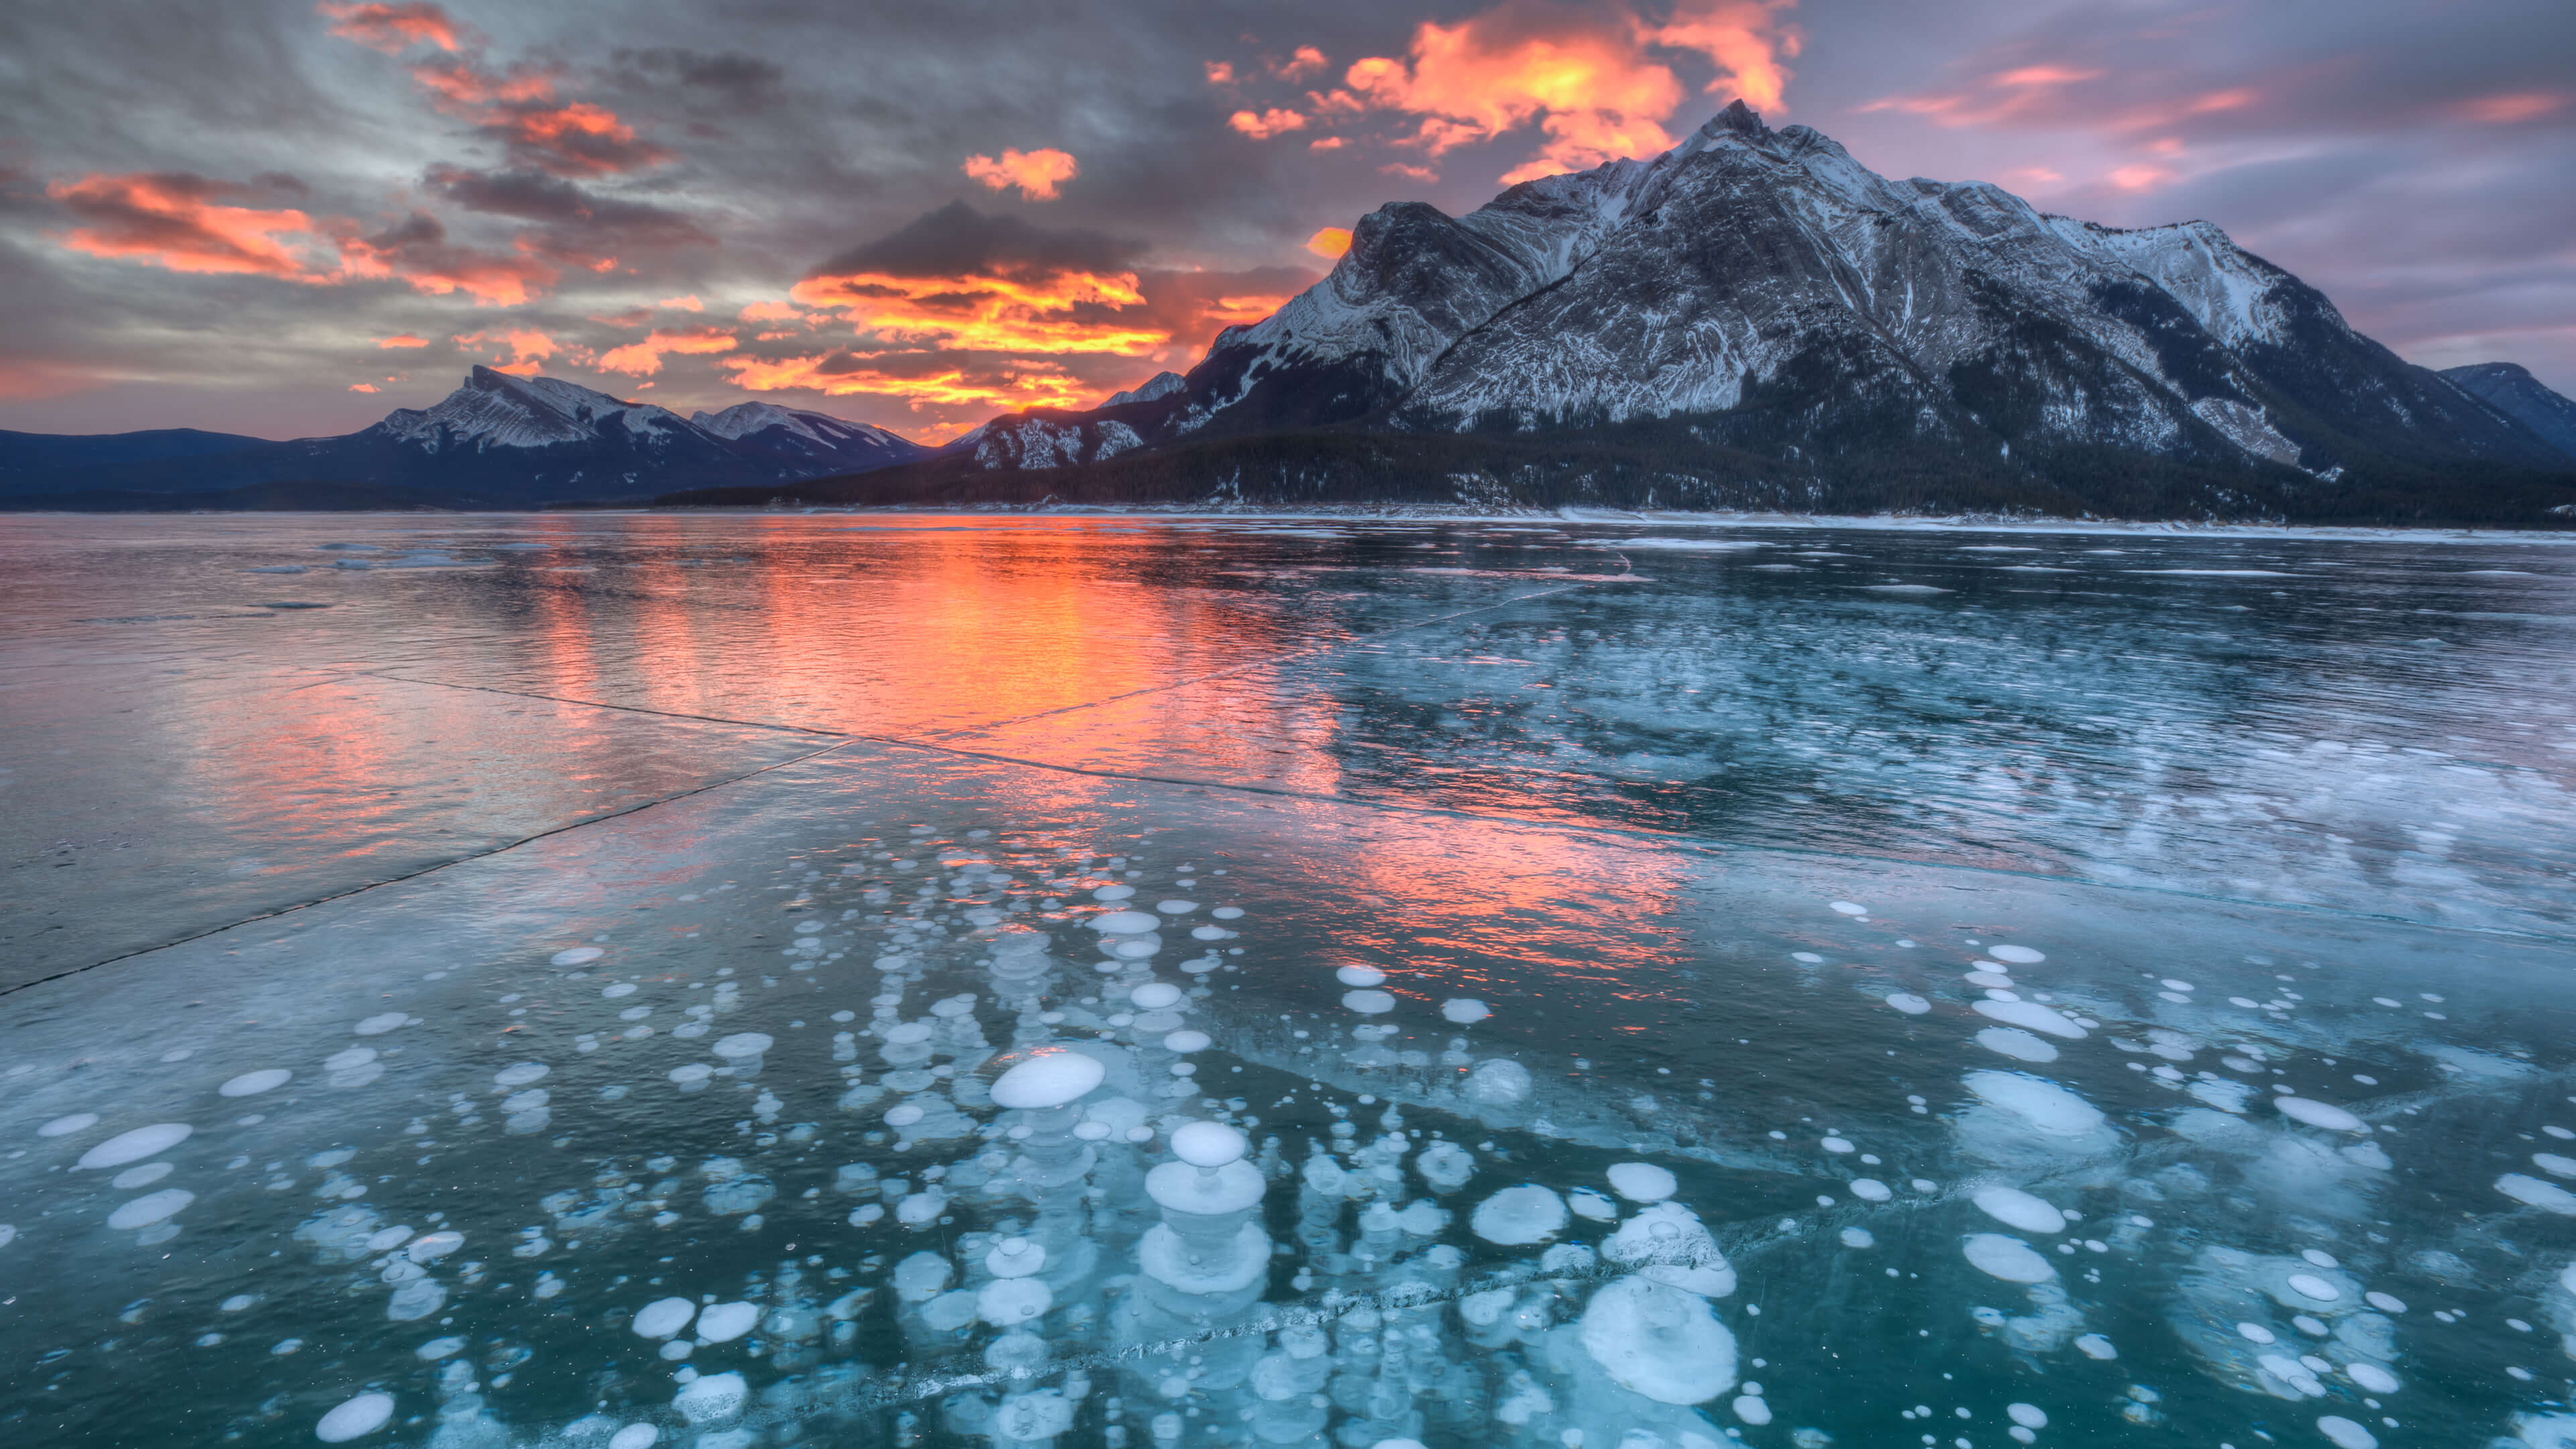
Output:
[46,173,337,284]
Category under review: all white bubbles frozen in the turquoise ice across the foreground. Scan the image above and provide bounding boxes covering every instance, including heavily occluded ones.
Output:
[15,835,2576,1449]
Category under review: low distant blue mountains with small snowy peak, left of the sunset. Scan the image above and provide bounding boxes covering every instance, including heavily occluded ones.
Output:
[0,366,930,508]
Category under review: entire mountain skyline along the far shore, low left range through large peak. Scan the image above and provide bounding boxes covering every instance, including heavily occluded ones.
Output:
[0,103,2576,526]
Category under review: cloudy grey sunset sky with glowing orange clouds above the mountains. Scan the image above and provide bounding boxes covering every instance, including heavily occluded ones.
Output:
[0,0,2576,441]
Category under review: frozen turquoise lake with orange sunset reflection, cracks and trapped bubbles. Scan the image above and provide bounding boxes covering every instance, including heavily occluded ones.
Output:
[0,516,2576,1449]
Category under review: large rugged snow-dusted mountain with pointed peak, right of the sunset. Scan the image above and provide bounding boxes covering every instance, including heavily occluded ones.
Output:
[943,103,2566,511]
